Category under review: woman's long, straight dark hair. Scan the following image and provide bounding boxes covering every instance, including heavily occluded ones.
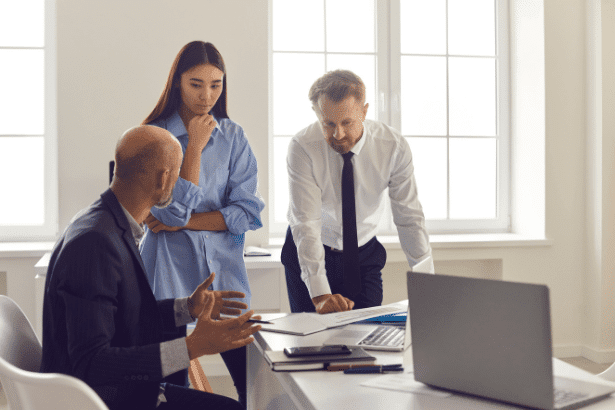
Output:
[142,41,228,124]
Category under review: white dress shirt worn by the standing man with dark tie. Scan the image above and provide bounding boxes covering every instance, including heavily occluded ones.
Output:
[287,120,434,298]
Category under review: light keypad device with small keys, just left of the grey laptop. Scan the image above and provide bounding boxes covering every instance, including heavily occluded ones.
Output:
[323,302,411,352]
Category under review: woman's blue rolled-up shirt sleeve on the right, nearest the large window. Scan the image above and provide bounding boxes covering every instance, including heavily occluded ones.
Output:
[220,129,265,235]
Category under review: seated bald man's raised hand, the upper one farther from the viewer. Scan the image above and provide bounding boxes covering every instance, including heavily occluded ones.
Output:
[188,272,248,320]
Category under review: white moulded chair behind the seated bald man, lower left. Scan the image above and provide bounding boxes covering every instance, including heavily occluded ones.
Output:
[0,295,107,410]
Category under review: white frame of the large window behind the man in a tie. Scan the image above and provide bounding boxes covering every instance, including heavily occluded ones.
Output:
[269,0,512,238]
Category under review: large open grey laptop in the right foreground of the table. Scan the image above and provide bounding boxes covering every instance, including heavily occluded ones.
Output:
[408,272,615,410]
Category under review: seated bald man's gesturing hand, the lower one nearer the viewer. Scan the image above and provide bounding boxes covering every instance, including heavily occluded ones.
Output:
[186,295,261,360]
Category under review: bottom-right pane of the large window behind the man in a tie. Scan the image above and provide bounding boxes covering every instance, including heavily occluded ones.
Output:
[449,138,497,219]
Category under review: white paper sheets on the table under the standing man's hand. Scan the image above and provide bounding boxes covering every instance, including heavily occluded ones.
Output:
[261,300,408,336]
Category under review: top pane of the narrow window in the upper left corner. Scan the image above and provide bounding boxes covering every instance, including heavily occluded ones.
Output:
[0,0,45,47]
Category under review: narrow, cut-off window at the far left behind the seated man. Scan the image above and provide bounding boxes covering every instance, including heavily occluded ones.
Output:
[0,0,57,240]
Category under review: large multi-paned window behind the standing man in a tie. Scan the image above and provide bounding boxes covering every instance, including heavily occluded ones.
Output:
[270,0,510,237]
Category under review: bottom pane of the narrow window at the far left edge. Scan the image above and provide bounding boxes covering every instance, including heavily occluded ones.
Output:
[0,137,45,226]
